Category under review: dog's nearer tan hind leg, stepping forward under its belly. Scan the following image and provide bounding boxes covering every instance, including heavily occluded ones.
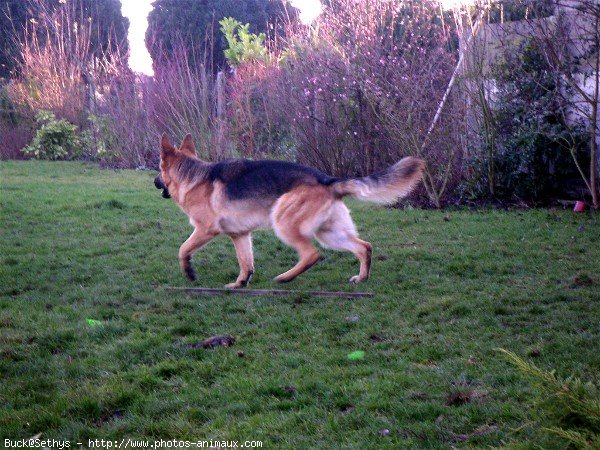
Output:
[271,186,332,283]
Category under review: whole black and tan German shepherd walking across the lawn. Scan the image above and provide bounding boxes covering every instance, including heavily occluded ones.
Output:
[154,134,424,288]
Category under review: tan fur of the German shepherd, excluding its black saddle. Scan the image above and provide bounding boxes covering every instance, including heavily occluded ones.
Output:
[160,135,423,288]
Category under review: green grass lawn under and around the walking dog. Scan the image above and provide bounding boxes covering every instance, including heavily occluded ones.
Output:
[0,162,600,449]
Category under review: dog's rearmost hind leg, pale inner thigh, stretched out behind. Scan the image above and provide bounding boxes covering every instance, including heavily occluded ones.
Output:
[315,201,373,283]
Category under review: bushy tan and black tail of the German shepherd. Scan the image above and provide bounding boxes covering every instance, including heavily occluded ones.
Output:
[331,156,425,204]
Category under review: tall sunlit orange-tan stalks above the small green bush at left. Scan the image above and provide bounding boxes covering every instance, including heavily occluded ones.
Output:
[10,0,126,127]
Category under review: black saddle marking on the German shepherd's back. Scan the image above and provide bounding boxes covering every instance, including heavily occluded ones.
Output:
[208,159,339,200]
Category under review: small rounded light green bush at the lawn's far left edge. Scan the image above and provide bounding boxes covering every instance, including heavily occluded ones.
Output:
[23,111,81,160]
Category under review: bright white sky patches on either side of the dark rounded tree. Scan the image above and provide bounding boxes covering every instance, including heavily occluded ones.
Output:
[121,0,322,75]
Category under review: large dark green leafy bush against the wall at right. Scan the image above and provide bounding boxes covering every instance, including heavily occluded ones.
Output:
[471,40,586,201]
